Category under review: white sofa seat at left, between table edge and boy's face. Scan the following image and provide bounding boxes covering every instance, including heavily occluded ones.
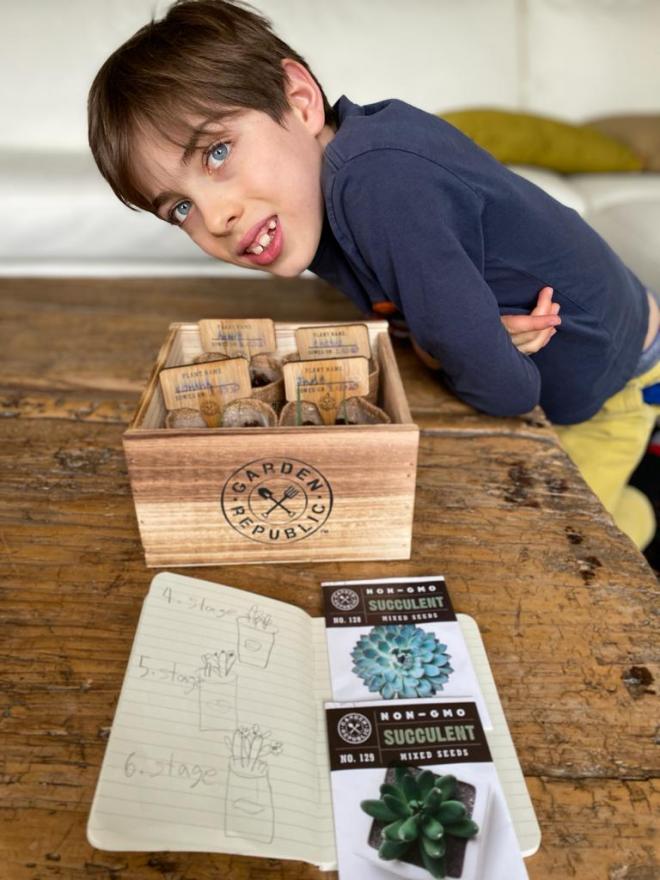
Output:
[0,152,263,275]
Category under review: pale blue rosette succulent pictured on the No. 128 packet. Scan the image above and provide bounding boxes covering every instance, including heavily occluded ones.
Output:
[351,623,454,700]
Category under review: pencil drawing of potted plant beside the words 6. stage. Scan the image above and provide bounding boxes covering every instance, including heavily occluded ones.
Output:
[225,724,283,843]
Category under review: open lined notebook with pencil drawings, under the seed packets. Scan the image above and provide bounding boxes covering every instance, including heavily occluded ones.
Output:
[87,572,540,869]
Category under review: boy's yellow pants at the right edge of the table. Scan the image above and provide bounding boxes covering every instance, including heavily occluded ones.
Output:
[554,363,660,550]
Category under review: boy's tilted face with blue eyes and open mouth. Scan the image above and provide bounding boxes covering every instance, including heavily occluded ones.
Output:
[138,98,333,278]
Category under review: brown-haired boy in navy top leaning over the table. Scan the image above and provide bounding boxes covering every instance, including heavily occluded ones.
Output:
[89,0,660,546]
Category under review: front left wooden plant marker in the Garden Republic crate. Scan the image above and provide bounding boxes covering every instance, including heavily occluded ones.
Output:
[158,357,252,428]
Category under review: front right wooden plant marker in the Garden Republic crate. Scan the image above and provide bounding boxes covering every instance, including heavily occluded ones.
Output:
[283,357,369,425]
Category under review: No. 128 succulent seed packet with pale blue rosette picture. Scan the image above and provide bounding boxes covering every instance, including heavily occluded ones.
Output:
[322,576,492,730]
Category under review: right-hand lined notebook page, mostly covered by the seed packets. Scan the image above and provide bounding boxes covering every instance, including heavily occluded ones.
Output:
[456,614,541,856]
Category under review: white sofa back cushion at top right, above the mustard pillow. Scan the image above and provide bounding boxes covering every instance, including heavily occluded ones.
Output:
[523,0,660,120]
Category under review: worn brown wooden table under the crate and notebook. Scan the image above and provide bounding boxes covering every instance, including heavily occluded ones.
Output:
[0,279,660,880]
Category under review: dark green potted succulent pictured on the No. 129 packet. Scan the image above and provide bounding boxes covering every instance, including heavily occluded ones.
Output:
[360,767,488,880]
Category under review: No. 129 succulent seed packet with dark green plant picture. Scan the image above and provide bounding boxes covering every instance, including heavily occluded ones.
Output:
[326,700,527,880]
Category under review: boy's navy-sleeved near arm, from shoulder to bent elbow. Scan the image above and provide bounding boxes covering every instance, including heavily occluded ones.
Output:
[332,150,541,416]
